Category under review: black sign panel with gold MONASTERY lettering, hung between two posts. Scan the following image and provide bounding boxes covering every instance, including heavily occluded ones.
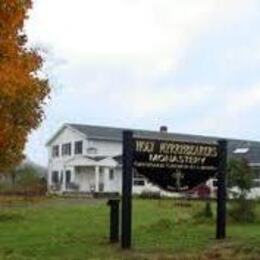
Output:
[133,138,219,191]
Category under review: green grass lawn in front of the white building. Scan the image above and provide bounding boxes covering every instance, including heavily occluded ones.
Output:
[0,199,260,260]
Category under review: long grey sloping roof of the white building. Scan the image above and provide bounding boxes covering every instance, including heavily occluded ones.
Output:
[68,124,260,163]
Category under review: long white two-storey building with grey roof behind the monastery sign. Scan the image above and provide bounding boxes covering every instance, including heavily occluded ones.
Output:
[46,124,260,195]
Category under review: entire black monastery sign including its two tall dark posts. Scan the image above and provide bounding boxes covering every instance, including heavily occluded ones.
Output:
[121,131,227,249]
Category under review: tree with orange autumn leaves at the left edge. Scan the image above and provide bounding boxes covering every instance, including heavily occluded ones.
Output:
[0,0,50,172]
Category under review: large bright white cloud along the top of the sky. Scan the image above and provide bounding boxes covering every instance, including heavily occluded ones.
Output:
[27,0,255,70]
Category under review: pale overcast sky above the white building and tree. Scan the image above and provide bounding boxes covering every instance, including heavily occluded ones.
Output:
[26,0,260,165]
